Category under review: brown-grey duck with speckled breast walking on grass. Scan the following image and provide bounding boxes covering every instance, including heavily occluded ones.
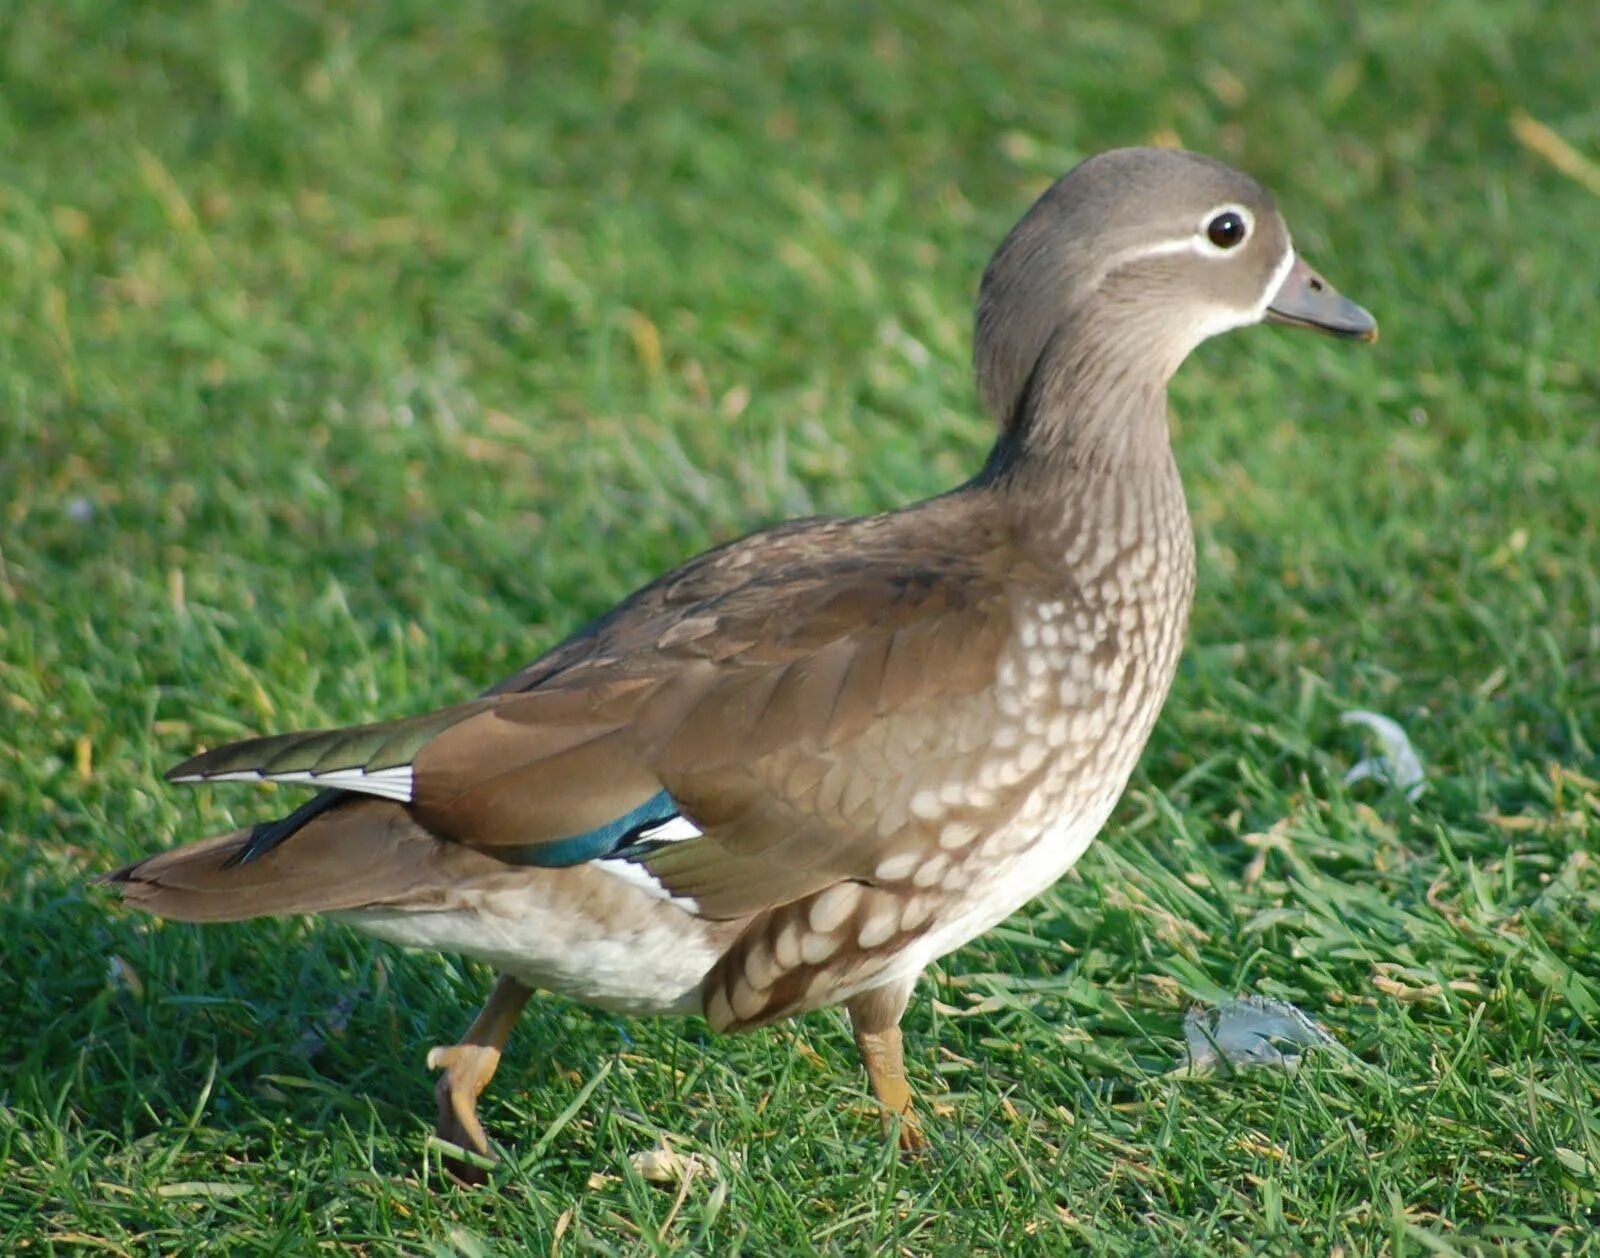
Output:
[99,147,1378,1165]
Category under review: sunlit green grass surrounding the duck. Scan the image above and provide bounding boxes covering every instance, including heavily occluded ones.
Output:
[0,0,1600,1255]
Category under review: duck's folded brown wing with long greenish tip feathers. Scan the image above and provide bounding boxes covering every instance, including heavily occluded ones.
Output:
[159,499,1016,917]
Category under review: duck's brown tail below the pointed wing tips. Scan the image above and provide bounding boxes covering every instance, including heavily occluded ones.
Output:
[94,799,506,922]
